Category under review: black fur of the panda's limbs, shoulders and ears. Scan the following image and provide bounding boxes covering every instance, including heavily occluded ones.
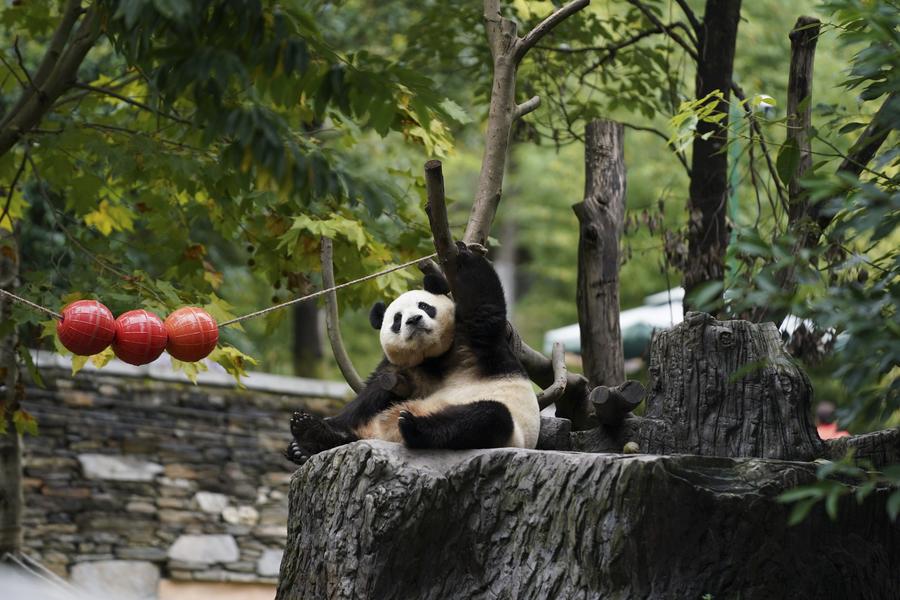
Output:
[285,242,527,464]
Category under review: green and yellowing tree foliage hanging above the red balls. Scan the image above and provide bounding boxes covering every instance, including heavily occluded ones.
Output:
[0,0,463,374]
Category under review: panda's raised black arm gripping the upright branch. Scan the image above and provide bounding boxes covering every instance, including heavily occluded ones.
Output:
[455,242,506,343]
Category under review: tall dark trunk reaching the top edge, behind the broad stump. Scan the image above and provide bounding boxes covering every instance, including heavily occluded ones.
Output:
[684,0,741,312]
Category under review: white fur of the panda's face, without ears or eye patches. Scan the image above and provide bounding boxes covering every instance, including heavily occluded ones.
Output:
[380,290,455,367]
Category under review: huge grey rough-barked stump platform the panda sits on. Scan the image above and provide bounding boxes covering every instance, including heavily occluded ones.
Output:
[277,441,900,600]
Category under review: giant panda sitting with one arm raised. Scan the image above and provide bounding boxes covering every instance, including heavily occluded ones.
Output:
[285,242,540,464]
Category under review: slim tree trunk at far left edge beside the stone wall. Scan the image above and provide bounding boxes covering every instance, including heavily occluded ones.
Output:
[0,229,25,557]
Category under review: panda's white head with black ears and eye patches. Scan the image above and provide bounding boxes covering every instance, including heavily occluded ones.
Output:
[369,274,455,367]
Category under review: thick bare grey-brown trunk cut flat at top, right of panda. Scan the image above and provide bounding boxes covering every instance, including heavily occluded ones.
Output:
[572,120,625,387]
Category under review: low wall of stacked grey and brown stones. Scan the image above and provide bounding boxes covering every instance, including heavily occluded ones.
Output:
[24,352,346,586]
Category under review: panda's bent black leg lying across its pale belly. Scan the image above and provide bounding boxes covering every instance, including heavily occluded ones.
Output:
[398,400,513,450]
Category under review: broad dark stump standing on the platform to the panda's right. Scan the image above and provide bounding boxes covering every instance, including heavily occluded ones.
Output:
[637,312,823,460]
